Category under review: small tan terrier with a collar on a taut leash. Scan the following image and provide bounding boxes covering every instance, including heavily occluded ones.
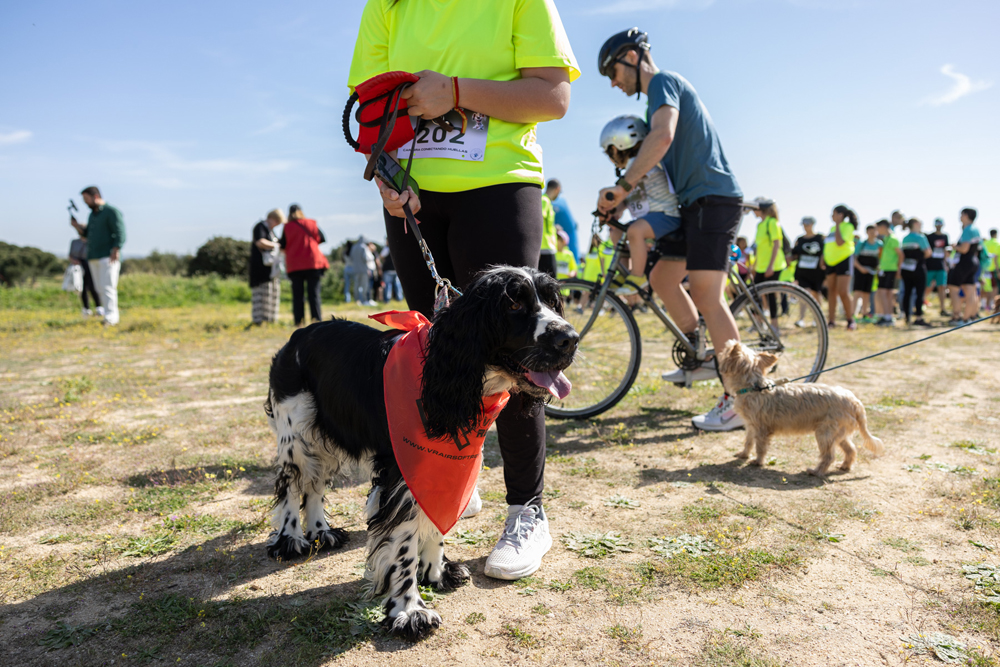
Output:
[719,341,885,477]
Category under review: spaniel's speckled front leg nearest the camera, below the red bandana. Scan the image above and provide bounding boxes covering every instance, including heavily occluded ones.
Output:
[365,480,441,641]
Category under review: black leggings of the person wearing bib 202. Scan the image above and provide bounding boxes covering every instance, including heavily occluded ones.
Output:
[383,183,545,505]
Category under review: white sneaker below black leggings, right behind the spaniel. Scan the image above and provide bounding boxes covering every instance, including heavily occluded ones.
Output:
[485,498,552,581]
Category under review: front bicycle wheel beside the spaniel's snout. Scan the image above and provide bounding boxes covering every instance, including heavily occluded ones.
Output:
[545,278,642,419]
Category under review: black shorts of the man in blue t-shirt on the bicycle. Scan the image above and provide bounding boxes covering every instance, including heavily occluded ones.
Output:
[681,195,743,271]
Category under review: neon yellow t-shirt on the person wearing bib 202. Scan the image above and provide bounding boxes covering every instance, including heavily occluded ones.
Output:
[347,0,580,192]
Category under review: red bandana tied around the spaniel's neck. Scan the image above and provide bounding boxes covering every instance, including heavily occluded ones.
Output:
[369,310,510,535]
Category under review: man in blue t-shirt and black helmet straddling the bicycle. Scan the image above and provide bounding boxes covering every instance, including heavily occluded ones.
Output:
[597,28,743,431]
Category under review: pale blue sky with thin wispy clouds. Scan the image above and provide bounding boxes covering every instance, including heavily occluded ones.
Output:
[0,0,1000,255]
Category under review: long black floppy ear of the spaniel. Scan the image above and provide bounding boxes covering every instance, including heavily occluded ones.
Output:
[421,274,510,438]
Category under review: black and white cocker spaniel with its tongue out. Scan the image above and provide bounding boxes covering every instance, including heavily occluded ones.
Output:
[264,266,579,639]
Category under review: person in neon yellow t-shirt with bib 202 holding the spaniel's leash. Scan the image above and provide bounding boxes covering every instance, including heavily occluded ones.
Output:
[347,0,580,584]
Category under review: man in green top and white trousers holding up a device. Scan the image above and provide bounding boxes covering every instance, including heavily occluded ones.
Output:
[70,185,125,326]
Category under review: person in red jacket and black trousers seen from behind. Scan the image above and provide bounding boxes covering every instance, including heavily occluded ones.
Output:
[279,204,330,326]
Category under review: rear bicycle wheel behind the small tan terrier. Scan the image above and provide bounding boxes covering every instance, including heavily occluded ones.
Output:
[730,281,830,382]
